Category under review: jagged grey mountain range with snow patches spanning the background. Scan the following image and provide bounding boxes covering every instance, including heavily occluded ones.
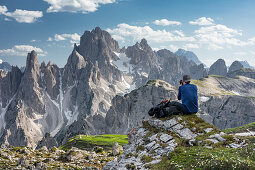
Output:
[0,27,254,148]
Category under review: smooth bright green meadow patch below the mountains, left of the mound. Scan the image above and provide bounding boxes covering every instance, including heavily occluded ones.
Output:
[59,134,128,150]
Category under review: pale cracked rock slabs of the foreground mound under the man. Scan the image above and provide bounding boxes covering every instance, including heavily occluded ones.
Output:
[103,115,247,170]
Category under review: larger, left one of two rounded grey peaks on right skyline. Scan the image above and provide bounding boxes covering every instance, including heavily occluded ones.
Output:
[208,59,227,76]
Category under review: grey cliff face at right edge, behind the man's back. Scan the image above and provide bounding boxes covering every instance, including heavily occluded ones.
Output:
[200,95,255,129]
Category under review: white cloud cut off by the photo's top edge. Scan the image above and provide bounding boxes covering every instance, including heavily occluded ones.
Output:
[44,0,116,13]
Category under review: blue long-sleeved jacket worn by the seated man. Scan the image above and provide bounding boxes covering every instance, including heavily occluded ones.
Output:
[178,84,198,113]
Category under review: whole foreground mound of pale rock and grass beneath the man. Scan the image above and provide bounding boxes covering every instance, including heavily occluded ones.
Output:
[103,115,255,170]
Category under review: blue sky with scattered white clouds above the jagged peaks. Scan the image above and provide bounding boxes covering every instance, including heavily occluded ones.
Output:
[0,0,255,67]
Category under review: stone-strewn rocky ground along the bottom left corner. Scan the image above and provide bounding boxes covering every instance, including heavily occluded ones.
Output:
[0,146,122,170]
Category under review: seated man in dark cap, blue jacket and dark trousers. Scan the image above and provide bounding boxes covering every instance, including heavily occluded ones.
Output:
[163,75,198,115]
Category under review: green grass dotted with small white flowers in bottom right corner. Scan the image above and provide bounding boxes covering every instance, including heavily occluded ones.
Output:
[150,145,255,170]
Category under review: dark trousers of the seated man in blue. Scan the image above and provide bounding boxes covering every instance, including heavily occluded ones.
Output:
[165,101,190,115]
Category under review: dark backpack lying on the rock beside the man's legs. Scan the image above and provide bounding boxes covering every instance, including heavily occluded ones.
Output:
[148,100,170,118]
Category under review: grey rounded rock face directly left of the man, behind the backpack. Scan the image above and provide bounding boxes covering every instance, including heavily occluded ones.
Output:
[105,80,176,134]
